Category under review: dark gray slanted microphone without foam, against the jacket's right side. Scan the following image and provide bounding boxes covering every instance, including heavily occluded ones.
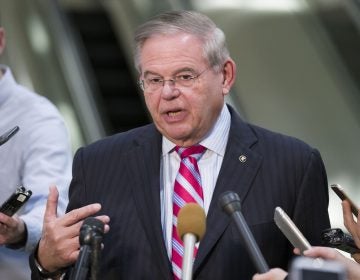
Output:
[219,191,269,273]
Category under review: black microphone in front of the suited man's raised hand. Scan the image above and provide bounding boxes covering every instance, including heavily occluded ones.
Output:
[70,217,104,280]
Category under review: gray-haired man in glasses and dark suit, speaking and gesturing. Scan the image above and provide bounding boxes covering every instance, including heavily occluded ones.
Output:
[30,11,329,279]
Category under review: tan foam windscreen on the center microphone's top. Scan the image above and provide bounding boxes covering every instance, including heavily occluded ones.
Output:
[177,203,206,242]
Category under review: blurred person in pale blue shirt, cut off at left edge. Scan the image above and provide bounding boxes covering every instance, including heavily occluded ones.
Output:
[0,26,72,280]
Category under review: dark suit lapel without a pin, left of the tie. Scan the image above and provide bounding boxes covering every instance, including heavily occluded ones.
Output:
[127,126,171,279]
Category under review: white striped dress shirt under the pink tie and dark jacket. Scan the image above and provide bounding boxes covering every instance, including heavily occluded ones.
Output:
[160,104,231,259]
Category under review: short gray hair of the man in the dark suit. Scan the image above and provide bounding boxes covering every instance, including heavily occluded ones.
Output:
[134,11,229,73]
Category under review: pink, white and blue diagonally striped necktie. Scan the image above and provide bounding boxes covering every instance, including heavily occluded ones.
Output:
[171,145,206,280]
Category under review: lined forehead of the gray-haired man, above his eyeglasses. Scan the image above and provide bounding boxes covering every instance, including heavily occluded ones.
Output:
[140,33,206,72]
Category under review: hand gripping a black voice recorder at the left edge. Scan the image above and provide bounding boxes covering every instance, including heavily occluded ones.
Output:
[0,213,26,245]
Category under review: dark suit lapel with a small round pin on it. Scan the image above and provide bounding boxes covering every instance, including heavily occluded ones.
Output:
[194,108,262,273]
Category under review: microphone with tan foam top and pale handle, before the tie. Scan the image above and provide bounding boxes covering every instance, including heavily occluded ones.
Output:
[177,203,206,280]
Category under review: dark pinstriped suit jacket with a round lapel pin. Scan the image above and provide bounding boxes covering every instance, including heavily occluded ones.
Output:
[33,105,330,280]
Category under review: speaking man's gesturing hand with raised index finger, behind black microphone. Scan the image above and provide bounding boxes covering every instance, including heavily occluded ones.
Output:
[37,186,110,272]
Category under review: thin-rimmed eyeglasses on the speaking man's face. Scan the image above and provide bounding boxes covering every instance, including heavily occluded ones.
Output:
[138,68,210,92]
